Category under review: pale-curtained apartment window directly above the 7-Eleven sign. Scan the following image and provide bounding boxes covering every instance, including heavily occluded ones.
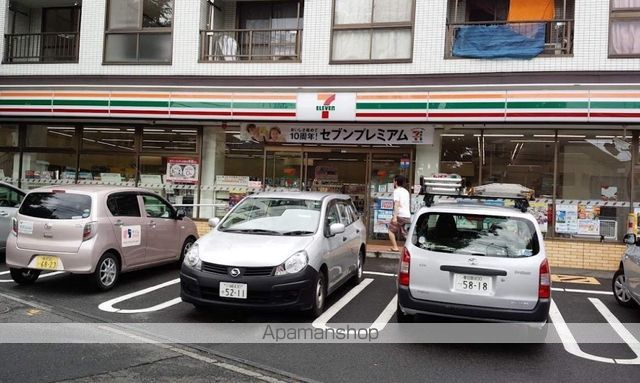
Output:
[331,0,415,63]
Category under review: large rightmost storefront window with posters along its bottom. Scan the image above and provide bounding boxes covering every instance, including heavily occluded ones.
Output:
[555,130,631,240]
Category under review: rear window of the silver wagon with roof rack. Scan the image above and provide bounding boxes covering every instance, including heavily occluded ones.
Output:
[412,213,540,258]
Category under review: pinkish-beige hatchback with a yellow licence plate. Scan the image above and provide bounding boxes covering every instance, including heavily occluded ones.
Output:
[6,185,198,290]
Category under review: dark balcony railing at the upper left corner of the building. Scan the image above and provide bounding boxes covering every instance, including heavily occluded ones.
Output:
[4,32,80,64]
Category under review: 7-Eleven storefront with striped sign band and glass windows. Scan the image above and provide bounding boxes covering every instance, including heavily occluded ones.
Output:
[0,84,640,268]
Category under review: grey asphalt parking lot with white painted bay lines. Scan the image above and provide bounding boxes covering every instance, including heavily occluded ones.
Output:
[0,258,640,382]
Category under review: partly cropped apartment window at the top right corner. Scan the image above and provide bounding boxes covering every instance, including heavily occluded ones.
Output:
[609,0,640,57]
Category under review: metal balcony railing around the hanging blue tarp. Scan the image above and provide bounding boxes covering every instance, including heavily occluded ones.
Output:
[445,20,573,58]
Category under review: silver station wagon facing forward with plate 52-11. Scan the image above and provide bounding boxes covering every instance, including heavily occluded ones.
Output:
[180,192,366,316]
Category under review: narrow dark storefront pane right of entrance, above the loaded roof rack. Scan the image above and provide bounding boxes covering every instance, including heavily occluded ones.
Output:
[440,129,481,187]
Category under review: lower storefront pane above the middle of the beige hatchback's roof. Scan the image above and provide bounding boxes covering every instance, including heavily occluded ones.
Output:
[78,153,136,185]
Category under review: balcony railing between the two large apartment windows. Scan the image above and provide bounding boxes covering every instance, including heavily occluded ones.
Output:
[200,29,302,62]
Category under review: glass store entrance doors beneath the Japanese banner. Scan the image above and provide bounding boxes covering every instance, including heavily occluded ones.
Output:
[265,146,413,244]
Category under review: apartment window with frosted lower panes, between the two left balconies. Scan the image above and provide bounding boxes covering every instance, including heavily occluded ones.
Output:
[104,0,173,64]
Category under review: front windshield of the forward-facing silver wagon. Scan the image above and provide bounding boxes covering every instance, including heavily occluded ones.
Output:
[219,198,322,236]
